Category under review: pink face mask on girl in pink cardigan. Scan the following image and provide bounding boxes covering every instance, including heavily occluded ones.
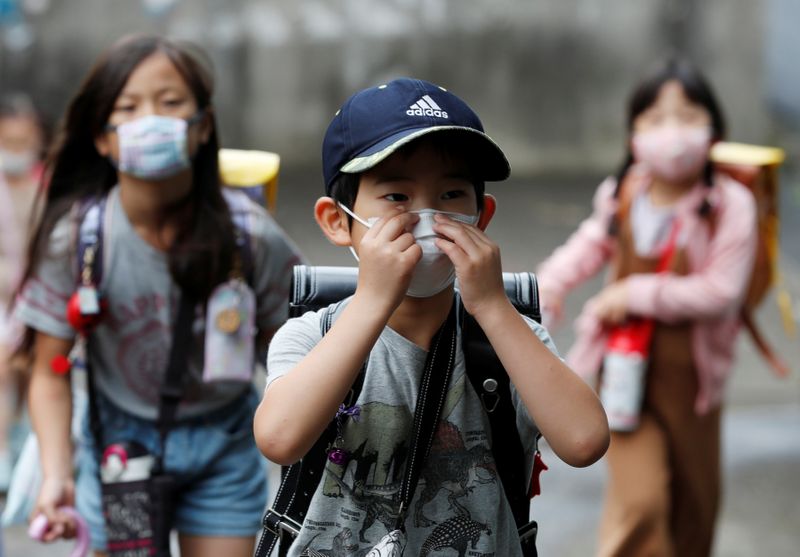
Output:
[631,126,711,182]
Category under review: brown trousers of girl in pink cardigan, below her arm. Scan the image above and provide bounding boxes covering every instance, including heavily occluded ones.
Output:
[598,325,720,557]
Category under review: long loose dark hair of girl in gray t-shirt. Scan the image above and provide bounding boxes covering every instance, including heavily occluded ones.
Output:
[15,35,236,348]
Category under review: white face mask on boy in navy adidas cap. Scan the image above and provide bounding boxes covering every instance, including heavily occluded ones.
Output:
[339,203,478,298]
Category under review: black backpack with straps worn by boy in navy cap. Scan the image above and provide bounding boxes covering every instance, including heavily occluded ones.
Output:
[255,265,541,557]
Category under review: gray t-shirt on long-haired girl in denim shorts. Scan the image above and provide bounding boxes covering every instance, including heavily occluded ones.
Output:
[16,188,301,419]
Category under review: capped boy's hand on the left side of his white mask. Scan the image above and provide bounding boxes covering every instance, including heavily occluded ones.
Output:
[356,207,422,313]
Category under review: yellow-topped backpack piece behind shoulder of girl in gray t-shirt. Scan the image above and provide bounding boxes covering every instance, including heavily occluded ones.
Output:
[219,149,281,213]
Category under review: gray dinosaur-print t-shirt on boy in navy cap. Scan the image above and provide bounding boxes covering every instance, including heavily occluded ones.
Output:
[267,301,556,556]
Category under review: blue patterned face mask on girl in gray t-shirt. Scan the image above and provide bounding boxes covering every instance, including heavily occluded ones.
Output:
[107,112,203,180]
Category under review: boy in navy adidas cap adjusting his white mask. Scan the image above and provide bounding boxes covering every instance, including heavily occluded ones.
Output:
[254,78,608,556]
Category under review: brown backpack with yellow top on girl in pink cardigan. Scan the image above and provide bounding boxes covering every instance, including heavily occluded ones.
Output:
[710,142,795,375]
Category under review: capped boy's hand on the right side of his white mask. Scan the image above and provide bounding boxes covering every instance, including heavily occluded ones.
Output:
[433,214,507,319]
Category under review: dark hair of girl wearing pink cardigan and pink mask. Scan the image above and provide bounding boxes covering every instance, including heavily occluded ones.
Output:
[611,58,726,231]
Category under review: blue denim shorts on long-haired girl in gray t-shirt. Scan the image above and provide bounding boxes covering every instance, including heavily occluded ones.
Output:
[75,391,267,551]
